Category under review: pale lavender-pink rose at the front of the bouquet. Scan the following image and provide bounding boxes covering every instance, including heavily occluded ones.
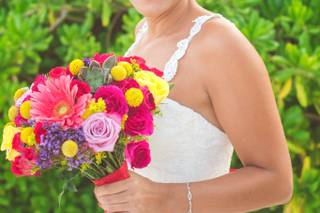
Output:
[82,112,121,152]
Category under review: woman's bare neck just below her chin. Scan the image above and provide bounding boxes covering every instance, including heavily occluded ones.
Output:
[145,0,198,38]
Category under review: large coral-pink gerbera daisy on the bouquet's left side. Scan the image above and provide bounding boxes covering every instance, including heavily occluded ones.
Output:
[30,75,91,128]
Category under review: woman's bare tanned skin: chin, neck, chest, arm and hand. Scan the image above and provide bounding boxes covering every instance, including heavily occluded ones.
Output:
[95,0,293,213]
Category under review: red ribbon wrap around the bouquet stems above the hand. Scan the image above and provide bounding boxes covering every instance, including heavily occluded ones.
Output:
[92,160,130,213]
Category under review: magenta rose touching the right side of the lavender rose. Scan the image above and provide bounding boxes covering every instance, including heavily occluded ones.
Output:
[124,108,153,136]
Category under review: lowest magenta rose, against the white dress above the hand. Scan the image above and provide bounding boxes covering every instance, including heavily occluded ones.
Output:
[125,140,151,169]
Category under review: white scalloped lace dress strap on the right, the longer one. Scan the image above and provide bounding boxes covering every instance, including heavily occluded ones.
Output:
[163,13,222,81]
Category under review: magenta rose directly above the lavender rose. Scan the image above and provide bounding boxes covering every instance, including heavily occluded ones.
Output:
[94,85,129,117]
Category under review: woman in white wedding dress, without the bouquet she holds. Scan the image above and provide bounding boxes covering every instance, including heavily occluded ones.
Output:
[95,0,293,213]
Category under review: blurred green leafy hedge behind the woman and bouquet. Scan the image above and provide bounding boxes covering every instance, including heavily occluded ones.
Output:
[0,0,320,213]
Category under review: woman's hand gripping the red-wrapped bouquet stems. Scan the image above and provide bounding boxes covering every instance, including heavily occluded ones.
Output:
[94,171,170,213]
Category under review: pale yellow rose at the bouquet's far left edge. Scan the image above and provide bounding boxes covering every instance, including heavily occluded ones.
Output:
[1,124,20,161]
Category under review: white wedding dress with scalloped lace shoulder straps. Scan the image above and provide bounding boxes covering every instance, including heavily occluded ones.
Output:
[125,13,233,183]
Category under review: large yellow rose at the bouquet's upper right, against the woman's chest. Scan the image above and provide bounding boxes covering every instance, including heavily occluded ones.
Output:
[134,71,169,105]
